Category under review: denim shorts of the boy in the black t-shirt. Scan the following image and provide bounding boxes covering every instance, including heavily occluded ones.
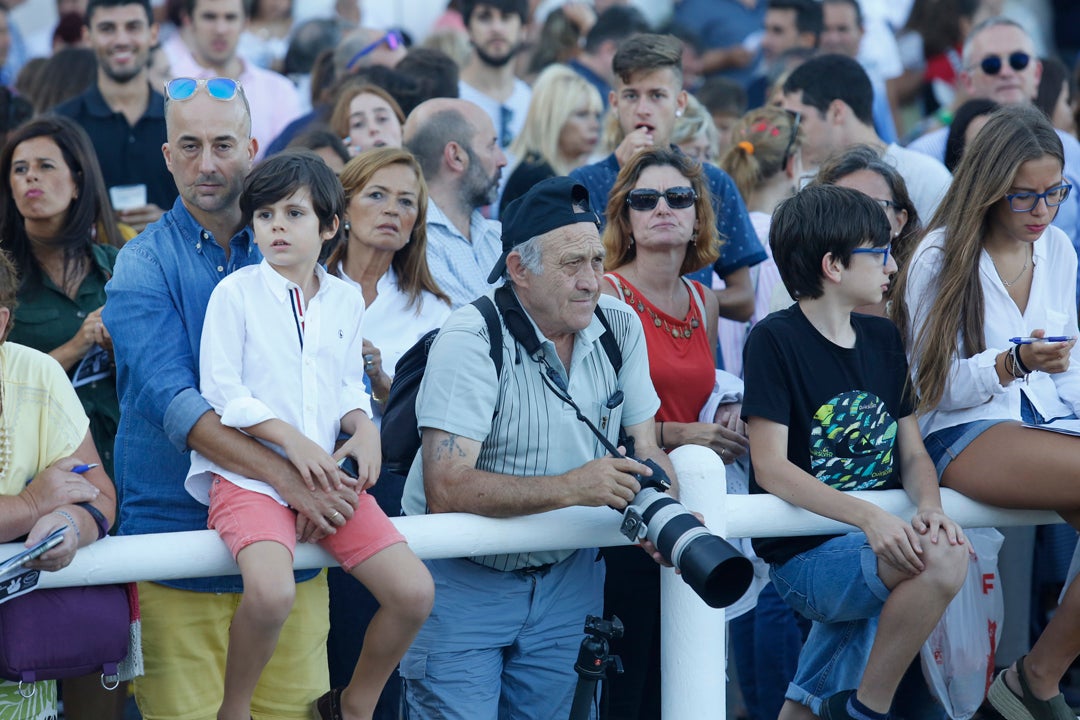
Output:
[769,532,889,715]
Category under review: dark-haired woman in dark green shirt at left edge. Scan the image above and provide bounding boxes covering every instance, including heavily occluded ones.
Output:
[0,116,123,477]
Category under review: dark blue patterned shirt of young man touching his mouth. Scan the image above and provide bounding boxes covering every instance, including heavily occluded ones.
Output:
[570,153,766,278]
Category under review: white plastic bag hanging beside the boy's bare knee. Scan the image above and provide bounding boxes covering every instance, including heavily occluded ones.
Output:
[919,528,1004,720]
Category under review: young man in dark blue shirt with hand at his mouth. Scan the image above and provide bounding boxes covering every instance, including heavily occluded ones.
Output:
[570,33,766,321]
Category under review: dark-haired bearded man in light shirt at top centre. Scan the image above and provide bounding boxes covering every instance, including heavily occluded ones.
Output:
[458,0,532,155]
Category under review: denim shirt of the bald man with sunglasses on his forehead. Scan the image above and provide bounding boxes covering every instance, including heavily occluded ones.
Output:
[103,199,315,593]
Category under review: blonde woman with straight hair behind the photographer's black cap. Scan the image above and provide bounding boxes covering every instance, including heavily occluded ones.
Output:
[499,65,604,213]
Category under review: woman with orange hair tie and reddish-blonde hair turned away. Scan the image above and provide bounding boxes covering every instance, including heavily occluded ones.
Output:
[717,106,802,379]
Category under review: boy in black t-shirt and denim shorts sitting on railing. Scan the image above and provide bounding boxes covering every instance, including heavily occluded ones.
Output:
[743,186,968,720]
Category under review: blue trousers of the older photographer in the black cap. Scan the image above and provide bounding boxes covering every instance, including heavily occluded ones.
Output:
[401,549,604,720]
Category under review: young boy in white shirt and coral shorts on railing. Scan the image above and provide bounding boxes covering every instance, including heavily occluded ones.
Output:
[186,151,434,720]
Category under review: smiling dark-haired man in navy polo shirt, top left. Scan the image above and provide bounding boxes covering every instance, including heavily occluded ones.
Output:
[54,0,176,230]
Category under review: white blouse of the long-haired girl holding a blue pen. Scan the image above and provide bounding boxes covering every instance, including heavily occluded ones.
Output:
[905,226,1080,436]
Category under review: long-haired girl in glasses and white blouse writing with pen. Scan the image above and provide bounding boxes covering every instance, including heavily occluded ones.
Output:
[892,105,1080,720]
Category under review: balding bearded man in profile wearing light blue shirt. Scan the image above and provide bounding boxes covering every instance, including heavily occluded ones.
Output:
[403,97,507,309]
